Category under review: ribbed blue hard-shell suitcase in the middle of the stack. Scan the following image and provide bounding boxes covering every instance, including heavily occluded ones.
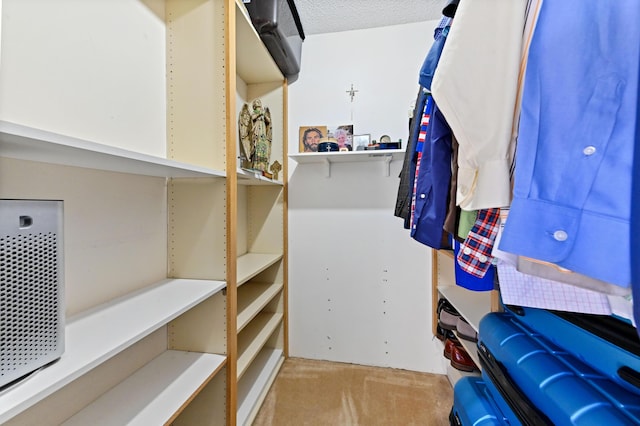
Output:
[478,312,640,426]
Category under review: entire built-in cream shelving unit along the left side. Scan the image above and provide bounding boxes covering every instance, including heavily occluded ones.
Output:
[0,0,287,425]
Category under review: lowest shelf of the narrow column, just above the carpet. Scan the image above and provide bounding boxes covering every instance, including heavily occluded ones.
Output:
[237,348,284,425]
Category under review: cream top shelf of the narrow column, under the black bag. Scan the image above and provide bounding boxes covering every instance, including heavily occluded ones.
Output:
[236,0,284,84]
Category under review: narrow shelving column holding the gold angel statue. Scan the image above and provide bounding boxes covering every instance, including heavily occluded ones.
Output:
[228,0,287,424]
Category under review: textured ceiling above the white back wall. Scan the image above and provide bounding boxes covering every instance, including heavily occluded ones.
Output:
[295,0,448,35]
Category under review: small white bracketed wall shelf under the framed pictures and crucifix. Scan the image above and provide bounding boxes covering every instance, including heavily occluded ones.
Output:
[289,149,405,177]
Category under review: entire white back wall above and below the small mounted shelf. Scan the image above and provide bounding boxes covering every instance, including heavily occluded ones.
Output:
[289,21,445,373]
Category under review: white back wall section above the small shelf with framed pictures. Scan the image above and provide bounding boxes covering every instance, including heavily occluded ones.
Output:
[289,21,437,146]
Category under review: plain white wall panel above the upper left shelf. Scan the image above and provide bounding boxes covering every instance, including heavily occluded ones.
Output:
[0,0,166,157]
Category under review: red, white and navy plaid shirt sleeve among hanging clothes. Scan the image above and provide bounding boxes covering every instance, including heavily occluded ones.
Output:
[457,209,500,278]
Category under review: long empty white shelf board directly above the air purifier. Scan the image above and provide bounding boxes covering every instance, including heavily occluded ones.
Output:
[0,121,225,178]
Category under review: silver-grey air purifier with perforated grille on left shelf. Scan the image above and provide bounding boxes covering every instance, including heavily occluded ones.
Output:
[0,200,64,386]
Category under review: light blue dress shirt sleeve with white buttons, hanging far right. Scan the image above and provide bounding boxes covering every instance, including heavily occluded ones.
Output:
[499,0,640,288]
